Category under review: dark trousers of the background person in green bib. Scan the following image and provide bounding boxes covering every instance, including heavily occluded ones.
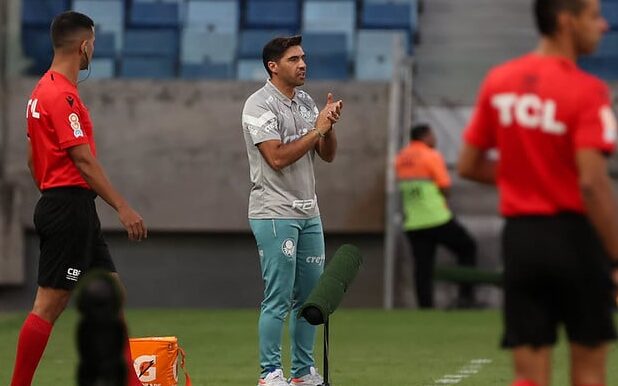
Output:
[406,218,476,308]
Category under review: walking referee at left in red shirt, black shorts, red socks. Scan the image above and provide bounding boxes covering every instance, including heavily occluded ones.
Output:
[11,11,147,386]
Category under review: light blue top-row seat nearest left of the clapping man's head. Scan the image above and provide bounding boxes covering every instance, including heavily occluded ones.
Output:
[185,0,240,34]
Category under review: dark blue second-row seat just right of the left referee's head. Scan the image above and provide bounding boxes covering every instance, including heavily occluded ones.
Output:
[122,29,178,58]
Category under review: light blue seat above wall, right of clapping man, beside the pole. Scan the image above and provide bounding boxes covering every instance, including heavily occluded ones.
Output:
[356,30,409,80]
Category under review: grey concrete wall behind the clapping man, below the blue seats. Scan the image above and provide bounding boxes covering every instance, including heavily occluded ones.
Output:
[0,78,388,310]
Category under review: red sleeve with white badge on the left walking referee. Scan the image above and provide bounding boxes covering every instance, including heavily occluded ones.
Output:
[48,92,88,149]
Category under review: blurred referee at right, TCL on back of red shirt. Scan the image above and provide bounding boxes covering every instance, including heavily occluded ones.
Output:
[458,0,618,386]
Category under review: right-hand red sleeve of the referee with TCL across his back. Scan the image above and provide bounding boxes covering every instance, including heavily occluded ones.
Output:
[573,81,618,153]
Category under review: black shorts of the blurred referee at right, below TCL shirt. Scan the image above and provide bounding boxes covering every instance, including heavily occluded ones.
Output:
[502,213,616,347]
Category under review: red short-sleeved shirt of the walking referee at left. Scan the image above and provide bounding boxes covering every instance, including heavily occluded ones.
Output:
[26,70,96,190]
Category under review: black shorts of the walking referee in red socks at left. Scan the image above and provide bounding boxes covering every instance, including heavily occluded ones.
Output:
[34,187,116,290]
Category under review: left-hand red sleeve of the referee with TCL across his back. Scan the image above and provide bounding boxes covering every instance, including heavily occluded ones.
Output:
[464,76,496,149]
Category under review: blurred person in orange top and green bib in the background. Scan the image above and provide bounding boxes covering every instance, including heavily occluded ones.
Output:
[395,124,476,308]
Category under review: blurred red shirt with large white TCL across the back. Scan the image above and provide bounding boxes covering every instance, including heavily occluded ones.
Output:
[464,54,617,216]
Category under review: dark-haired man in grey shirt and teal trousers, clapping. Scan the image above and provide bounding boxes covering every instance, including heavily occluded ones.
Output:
[242,36,343,386]
